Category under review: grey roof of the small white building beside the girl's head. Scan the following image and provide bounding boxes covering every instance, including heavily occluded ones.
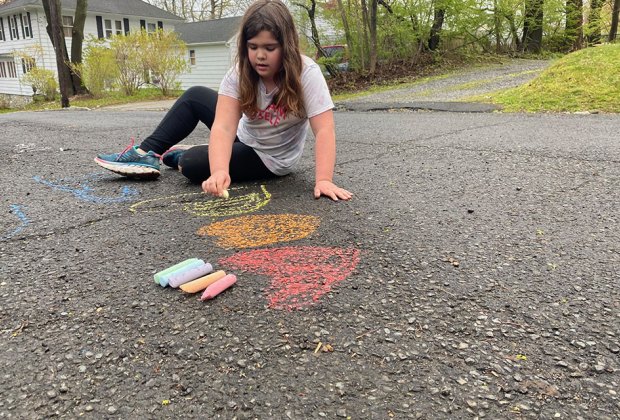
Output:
[174,16,241,44]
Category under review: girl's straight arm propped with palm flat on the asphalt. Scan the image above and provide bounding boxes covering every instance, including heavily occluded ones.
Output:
[310,110,353,201]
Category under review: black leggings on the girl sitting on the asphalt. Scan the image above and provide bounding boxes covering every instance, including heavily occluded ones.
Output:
[140,86,277,183]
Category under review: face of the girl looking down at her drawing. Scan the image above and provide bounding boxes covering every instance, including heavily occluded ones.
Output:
[247,31,282,87]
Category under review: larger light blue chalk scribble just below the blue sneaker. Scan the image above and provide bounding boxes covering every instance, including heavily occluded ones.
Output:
[34,173,138,204]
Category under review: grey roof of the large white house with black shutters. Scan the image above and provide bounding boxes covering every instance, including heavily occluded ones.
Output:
[0,0,183,20]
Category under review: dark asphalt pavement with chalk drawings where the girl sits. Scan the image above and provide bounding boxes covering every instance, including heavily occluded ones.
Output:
[0,63,620,419]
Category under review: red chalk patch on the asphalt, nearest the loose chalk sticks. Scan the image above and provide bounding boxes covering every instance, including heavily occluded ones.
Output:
[219,246,360,310]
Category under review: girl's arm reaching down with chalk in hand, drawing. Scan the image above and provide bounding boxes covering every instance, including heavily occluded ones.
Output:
[202,95,241,196]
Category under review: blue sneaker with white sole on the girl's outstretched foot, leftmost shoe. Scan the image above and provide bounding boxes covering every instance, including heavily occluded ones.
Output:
[95,138,160,179]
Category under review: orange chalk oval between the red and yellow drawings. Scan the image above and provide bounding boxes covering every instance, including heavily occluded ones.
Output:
[197,214,320,248]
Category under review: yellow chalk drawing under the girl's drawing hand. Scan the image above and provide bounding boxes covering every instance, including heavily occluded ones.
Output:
[129,185,271,217]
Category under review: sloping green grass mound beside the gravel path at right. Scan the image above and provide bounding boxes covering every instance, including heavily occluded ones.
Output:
[467,44,620,113]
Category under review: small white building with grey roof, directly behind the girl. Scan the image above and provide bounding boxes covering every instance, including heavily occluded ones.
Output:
[175,17,241,90]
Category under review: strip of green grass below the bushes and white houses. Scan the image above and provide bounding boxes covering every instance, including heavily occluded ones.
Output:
[0,88,183,113]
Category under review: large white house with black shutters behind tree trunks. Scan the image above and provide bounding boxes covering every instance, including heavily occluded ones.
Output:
[0,0,183,106]
